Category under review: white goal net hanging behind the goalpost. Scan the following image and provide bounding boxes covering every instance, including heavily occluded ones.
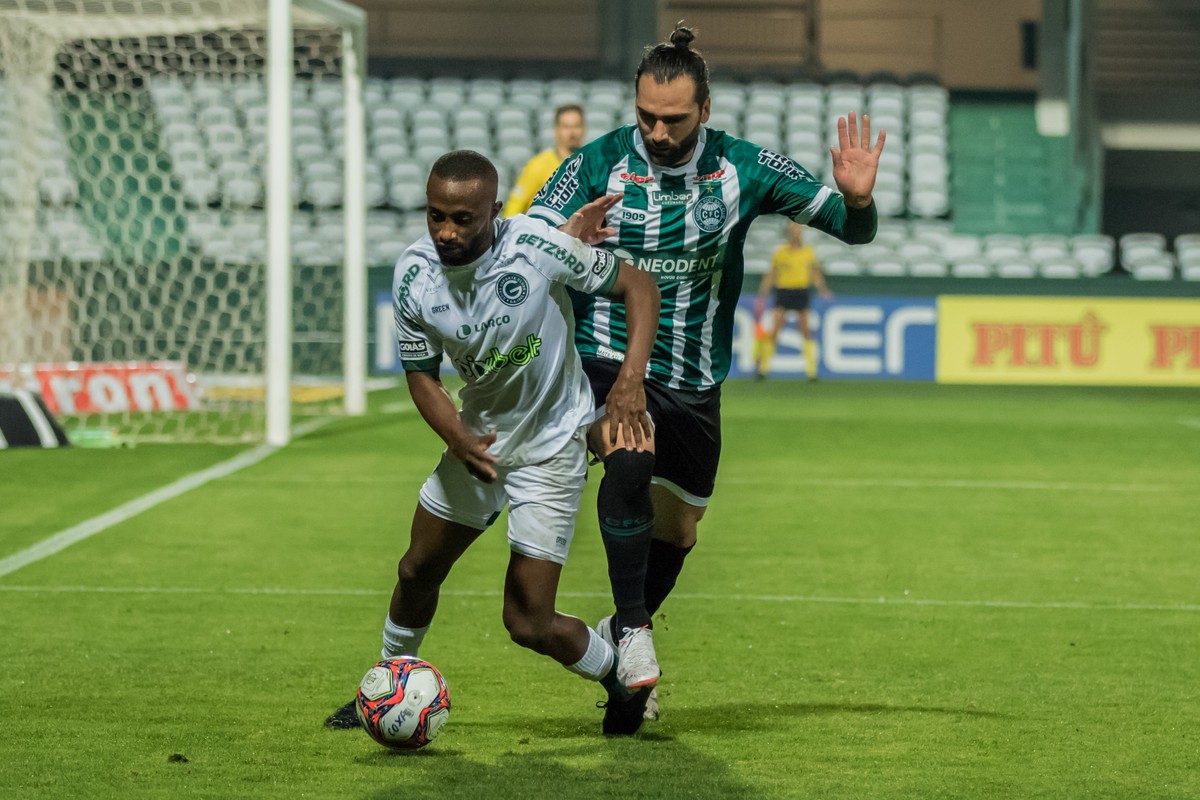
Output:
[0,0,365,441]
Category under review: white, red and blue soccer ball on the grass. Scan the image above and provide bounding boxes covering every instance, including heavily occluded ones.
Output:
[354,656,450,750]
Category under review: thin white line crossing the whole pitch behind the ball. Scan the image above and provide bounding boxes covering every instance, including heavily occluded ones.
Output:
[0,584,1200,612]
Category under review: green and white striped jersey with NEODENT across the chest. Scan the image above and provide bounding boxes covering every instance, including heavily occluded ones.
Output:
[528,125,874,390]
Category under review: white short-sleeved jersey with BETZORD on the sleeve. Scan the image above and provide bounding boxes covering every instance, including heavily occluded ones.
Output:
[392,215,617,467]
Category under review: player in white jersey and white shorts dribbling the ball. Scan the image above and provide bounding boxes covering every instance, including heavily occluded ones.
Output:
[325,150,659,735]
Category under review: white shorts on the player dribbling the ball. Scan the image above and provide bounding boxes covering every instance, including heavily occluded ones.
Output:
[420,426,588,564]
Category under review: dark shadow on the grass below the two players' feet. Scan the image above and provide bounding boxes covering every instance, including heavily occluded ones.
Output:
[358,703,1006,800]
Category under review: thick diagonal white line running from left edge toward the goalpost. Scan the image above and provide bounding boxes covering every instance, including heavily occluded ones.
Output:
[0,417,330,577]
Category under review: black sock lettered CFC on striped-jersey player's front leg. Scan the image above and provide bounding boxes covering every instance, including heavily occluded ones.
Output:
[596,450,654,638]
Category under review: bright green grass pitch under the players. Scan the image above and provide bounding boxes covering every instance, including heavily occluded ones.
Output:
[0,381,1200,800]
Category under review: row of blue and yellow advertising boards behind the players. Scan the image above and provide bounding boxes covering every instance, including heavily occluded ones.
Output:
[368,277,1200,386]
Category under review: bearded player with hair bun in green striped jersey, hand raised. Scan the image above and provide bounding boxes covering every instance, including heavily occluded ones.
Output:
[529,26,884,734]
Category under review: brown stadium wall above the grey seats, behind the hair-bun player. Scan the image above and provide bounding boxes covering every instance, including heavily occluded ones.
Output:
[352,0,1043,91]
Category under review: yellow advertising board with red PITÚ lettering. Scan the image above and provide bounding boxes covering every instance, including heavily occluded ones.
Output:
[937,295,1200,386]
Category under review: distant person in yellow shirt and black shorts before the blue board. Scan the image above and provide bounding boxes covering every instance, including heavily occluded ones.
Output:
[755,222,833,380]
